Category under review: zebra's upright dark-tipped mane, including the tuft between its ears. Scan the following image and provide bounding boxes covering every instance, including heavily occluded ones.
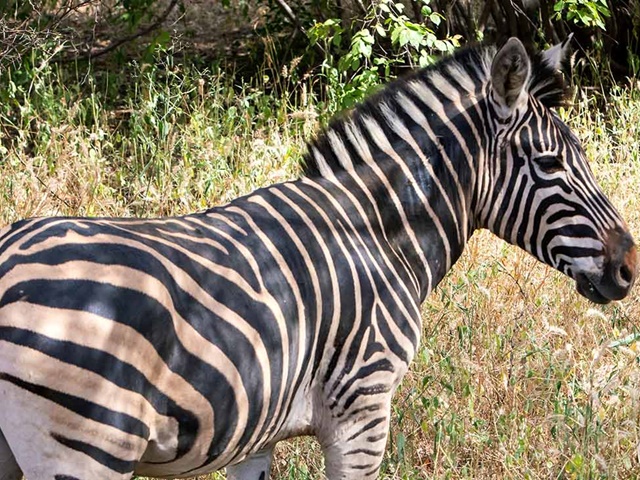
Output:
[302,41,569,177]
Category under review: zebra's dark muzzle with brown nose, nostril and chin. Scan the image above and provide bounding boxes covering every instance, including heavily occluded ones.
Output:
[575,228,637,304]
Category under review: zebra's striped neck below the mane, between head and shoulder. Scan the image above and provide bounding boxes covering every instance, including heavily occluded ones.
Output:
[310,124,483,301]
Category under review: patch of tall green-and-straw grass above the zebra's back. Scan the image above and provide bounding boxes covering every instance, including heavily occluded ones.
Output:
[0,50,315,219]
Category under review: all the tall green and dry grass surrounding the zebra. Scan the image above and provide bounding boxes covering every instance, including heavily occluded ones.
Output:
[0,46,640,479]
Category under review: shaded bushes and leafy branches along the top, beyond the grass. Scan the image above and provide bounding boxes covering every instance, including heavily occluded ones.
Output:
[0,0,640,94]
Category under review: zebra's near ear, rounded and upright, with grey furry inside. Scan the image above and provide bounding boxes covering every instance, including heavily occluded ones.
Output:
[491,37,531,110]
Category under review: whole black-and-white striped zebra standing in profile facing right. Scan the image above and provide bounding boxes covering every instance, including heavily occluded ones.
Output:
[0,38,636,480]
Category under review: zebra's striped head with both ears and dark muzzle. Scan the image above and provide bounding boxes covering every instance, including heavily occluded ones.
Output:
[478,38,636,303]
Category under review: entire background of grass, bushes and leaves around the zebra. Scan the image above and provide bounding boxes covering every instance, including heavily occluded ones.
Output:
[0,0,640,479]
